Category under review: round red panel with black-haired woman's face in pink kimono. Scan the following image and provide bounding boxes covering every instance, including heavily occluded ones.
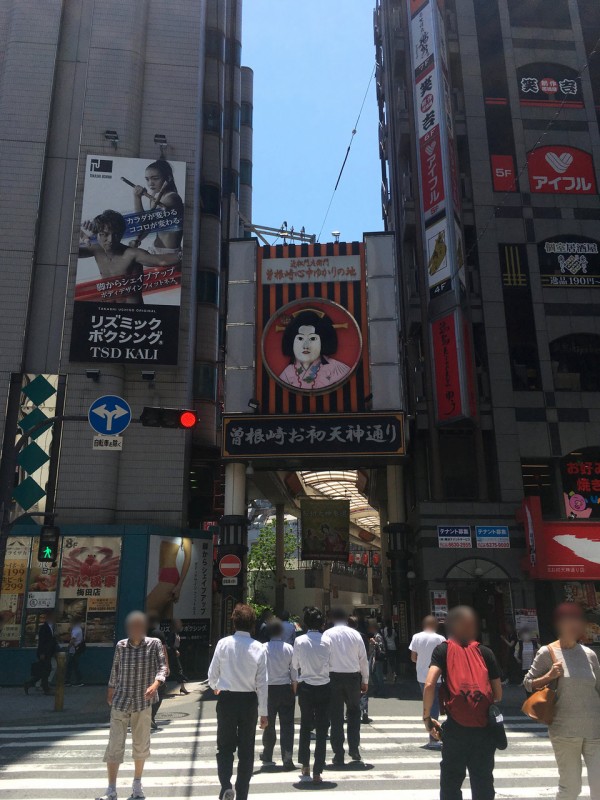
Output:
[262,297,362,394]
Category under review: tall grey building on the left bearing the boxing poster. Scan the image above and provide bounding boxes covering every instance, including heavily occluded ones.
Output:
[0,0,252,679]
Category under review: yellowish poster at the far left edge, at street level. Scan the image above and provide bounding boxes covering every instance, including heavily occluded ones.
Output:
[0,536,31,647]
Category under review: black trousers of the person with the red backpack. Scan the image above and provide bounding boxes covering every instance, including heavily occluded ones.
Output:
[440,717,496,800]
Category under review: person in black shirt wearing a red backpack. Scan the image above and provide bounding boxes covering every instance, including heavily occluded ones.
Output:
[423,606,502,800]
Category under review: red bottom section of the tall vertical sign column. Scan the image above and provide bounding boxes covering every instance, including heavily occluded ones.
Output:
[431,314,463,422]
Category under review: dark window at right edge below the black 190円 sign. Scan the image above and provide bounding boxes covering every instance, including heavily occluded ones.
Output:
[550,333,600,392]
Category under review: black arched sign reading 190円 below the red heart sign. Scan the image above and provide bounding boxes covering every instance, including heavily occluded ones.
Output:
[538,235,600,289]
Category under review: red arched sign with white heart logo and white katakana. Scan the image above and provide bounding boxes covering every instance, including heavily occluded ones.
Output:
[527,145,596,194]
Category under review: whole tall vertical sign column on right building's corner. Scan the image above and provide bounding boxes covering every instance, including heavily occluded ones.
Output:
[407,0,476,423]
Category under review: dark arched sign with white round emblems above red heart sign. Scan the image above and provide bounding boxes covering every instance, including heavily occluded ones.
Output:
[517,62,584,108]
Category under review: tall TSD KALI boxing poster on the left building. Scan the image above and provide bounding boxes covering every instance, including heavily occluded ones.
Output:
[70,156,186,365]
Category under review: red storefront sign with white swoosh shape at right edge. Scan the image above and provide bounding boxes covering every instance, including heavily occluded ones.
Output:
[521,497,600,581]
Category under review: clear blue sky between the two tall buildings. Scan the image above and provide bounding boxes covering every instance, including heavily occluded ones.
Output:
[242,0,383,242]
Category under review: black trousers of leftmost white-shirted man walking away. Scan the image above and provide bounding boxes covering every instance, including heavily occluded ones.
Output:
[217,692,258,800]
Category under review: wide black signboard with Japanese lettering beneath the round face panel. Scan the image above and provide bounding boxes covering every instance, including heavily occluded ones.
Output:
[222,412,405,459]
